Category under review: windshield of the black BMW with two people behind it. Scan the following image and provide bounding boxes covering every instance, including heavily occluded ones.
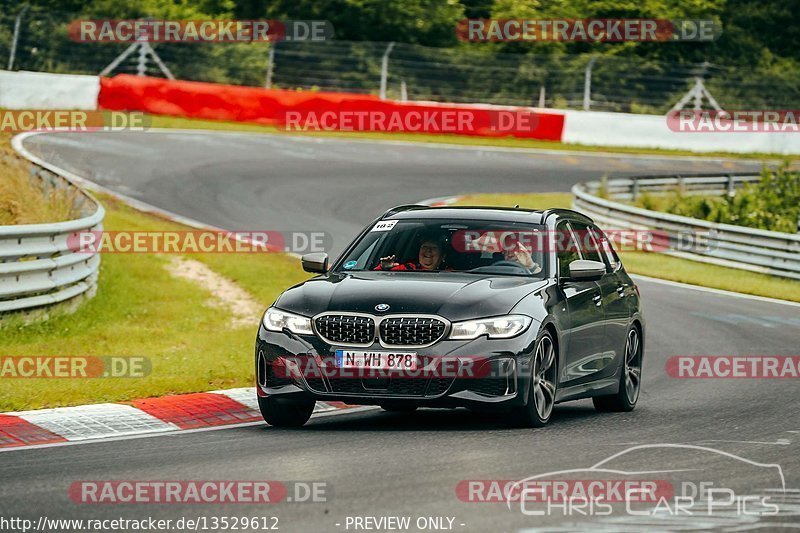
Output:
[337,220,546,277]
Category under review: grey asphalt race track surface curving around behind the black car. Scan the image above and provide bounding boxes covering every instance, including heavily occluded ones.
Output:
[0,132,800,531]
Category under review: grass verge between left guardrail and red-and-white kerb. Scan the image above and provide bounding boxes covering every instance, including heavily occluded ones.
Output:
[0,195,308,412]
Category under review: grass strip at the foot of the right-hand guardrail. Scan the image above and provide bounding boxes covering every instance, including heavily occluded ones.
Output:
[456,193,800,302]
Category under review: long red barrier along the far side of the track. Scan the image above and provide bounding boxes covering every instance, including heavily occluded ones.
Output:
[99,74,564,141]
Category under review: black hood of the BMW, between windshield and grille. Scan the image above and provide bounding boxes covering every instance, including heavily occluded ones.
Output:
[275,272,547,321]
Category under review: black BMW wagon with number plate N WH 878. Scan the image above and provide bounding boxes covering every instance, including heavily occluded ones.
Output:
[255,205,644,427]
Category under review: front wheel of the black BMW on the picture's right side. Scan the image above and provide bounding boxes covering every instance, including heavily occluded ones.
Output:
[511,330,558,428]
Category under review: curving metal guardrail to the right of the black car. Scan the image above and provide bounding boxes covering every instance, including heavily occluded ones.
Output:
[572,174,800,279]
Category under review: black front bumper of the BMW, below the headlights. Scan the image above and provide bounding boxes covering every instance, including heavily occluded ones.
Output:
[255,323,537,410]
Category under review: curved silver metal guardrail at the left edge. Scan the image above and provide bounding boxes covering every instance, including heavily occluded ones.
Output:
[0,165,105,313]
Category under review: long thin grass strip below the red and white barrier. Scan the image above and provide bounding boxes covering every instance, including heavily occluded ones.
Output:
[145,115,786,159]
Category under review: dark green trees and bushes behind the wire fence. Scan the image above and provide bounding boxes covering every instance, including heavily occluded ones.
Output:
[0,0,800,112]
